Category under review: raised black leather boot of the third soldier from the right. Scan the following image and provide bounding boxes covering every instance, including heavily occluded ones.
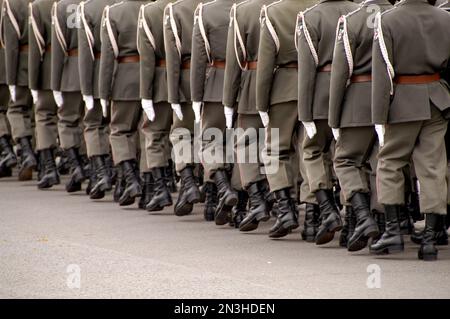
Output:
[316,190,342,245]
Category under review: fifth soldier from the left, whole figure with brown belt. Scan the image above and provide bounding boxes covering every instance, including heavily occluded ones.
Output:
[99,0,145,206]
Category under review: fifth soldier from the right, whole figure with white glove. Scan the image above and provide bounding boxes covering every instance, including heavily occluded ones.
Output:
[223,0,272,231]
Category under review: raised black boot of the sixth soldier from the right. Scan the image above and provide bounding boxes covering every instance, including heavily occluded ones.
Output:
[214,170,238,226]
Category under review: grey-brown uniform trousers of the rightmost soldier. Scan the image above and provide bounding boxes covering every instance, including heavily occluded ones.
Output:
[377,106,448,215]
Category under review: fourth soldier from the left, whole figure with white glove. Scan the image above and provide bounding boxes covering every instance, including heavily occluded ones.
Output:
[78,0,116,199]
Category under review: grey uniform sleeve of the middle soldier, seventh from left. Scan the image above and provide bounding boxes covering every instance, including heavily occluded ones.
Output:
[164,4,181,104]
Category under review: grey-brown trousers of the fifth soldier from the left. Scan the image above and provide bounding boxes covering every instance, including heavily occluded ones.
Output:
[110,101,141,165]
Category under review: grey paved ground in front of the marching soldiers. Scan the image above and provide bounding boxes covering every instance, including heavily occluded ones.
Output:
[0,178,450,298]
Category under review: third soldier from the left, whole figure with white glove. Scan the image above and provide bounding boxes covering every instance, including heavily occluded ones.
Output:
[51,0,86,193]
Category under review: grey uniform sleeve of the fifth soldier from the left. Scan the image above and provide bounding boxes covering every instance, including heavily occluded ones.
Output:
[99,8,118,100]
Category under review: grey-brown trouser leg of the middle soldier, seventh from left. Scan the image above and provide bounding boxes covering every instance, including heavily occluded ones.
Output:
[170,103,195,173]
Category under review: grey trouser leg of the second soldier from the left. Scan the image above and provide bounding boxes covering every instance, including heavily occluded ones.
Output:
[35,90,58,151]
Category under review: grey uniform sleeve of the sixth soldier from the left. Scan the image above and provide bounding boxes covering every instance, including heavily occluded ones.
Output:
[138,8,156,100]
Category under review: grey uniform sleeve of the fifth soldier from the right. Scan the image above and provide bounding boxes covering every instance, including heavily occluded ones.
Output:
[223,8,245,107]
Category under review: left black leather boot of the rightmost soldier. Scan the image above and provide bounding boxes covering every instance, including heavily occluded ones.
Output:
[370,205,405,255]
